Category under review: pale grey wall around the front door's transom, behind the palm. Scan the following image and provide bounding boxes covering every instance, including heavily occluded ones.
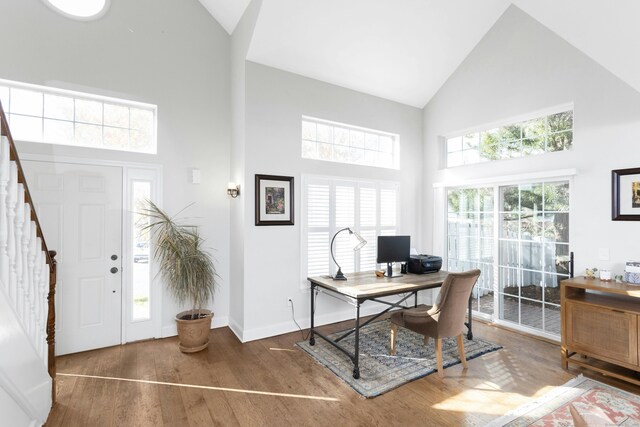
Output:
[0,0,230,334]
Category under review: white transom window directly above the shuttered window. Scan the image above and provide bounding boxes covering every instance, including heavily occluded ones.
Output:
[302,116,400,169]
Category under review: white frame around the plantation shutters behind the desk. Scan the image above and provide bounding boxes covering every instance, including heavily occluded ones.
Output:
[300,175,402,290]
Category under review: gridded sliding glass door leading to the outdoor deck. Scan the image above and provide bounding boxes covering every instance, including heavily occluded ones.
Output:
[447,181,569,336]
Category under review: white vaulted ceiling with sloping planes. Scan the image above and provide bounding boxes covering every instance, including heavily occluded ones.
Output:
[200,0,640,108]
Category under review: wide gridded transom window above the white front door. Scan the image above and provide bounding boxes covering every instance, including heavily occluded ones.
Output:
[0,80,157,154]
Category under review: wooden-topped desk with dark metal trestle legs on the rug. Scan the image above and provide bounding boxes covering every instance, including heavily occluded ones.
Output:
[307,271,473,379]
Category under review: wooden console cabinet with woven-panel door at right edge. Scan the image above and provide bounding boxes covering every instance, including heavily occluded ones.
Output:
[560,277,640,385]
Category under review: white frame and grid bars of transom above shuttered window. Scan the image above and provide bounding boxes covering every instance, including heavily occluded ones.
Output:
[300,116,400,170]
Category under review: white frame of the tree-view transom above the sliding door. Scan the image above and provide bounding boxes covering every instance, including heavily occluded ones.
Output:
[441,103,575,168]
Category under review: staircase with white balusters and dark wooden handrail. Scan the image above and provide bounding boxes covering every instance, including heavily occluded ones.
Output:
[0,105,56,426]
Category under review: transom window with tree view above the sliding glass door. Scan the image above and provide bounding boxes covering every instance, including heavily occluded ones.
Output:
[446,109,573,167]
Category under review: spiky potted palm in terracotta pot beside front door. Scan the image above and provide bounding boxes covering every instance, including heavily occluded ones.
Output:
[141,201,217,353]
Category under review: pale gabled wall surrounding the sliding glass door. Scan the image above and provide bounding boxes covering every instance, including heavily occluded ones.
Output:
[424,6,640,274]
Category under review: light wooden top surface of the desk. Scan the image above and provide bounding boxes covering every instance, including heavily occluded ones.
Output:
[307,270,448,298]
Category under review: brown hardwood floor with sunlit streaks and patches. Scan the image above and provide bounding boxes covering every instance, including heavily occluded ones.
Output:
[46,322,640,427]
